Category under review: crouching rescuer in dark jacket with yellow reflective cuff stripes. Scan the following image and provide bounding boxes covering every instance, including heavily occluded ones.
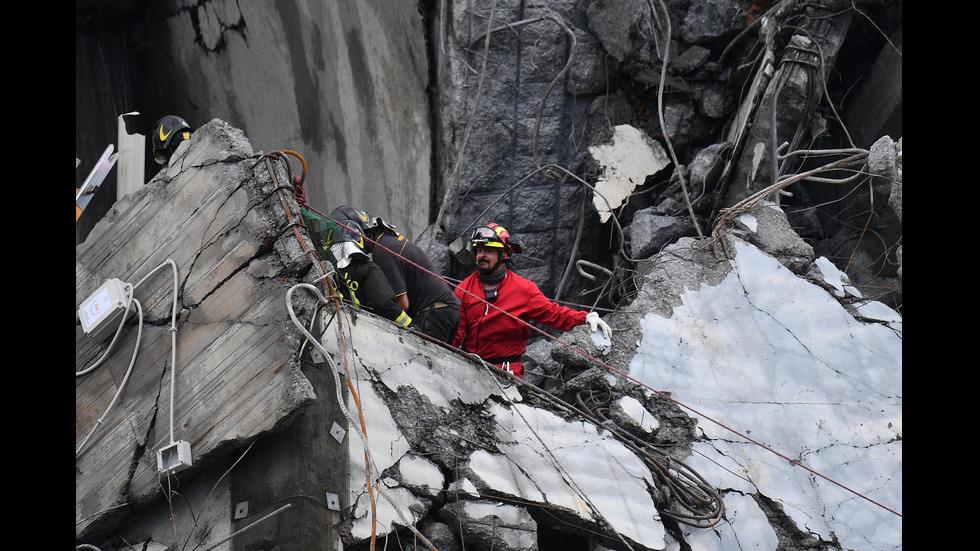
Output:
[326,209,412,327]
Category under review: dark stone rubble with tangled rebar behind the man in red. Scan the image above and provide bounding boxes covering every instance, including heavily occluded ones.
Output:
[439,0,902,309]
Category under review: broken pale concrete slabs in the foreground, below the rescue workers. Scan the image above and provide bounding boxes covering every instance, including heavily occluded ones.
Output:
[76,116,901,551]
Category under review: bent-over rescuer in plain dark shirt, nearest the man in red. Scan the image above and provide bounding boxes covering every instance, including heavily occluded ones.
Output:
[334,205,459,344]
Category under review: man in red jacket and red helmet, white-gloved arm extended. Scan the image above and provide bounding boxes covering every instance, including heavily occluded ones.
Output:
[453,223,612,379]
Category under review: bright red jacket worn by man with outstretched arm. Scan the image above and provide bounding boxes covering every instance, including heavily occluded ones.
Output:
[453,270,588,371]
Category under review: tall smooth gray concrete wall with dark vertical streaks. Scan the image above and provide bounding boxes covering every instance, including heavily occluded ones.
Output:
[147,0,432,237]
